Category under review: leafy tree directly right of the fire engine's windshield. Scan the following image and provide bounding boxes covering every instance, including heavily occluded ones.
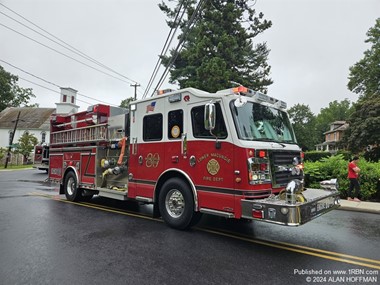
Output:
[288,104,318,151]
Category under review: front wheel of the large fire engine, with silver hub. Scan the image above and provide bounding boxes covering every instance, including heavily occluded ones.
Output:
[158,178,197,230]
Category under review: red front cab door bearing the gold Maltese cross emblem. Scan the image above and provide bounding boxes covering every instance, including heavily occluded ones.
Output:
[187,103,235,213]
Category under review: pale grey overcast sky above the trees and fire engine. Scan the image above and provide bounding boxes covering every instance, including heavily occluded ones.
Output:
[0,0,380,115]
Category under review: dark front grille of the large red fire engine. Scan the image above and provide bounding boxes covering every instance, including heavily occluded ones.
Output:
[270,151,303,187]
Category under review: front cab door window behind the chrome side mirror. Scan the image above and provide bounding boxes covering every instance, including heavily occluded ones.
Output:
[191,103,227,139]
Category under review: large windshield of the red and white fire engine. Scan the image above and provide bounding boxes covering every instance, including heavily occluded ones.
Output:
[230,101,297,143]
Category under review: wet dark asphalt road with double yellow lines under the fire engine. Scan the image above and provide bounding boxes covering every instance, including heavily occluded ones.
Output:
[0,170,380,284]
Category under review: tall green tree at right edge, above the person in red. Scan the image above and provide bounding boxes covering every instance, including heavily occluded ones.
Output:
[343,18,380,160]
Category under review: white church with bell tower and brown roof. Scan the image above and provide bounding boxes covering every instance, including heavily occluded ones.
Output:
[0,87,79,148]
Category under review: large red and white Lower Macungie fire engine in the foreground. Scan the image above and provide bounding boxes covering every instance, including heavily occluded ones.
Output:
[49,86,339,229]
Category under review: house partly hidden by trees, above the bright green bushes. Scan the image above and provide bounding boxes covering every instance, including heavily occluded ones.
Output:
[316,121,348,153]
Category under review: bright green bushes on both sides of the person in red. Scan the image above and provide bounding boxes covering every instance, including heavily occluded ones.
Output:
[305,154,380,200]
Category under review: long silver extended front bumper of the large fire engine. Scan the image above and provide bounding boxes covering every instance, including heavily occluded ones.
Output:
[241,189,340,226]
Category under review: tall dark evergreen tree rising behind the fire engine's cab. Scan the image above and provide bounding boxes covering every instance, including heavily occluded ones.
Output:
[159,0,272,92]
